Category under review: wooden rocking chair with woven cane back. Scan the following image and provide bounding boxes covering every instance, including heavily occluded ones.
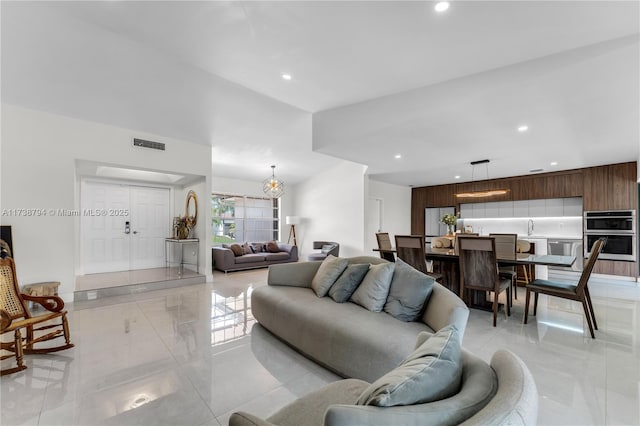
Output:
[0,258,73,376]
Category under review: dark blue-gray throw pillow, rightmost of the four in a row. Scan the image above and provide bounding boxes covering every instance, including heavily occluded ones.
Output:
[384,258,434,322]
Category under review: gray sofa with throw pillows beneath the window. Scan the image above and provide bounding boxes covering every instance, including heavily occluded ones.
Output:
[211,242,298,272]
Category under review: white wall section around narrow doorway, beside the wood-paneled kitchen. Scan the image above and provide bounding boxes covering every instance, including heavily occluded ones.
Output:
[364,179,411,254]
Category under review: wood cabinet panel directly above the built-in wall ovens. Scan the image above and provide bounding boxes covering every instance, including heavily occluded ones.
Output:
[582,162,638,210]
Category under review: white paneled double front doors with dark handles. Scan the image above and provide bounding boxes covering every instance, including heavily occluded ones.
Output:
[80,181,171,274]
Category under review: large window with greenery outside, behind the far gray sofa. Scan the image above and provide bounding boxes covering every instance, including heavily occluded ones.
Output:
[211,194,279,244]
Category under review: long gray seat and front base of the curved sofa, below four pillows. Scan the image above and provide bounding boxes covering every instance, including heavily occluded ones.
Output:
[251,284,430,383]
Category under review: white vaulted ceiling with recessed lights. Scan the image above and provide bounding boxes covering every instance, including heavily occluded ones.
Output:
[2,1,640,185]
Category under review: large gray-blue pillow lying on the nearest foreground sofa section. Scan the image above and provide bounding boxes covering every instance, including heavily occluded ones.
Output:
[356,325,462,407]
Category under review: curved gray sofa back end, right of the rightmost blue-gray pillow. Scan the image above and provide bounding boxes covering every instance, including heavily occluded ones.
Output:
[422,282,469,339]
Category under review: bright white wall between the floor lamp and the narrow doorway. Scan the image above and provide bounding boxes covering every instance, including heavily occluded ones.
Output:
[294,161,370,260]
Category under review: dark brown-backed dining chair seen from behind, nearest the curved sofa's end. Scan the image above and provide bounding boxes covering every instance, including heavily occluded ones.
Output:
[458,236,511,327]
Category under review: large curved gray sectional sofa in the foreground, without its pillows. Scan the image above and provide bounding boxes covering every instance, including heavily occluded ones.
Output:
[229,256,537,426]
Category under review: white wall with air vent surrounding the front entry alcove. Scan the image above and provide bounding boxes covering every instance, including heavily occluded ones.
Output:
[0,104,211,300]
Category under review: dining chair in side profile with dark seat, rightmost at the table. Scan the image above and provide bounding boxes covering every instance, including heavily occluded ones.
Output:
[524,238,607,339]
